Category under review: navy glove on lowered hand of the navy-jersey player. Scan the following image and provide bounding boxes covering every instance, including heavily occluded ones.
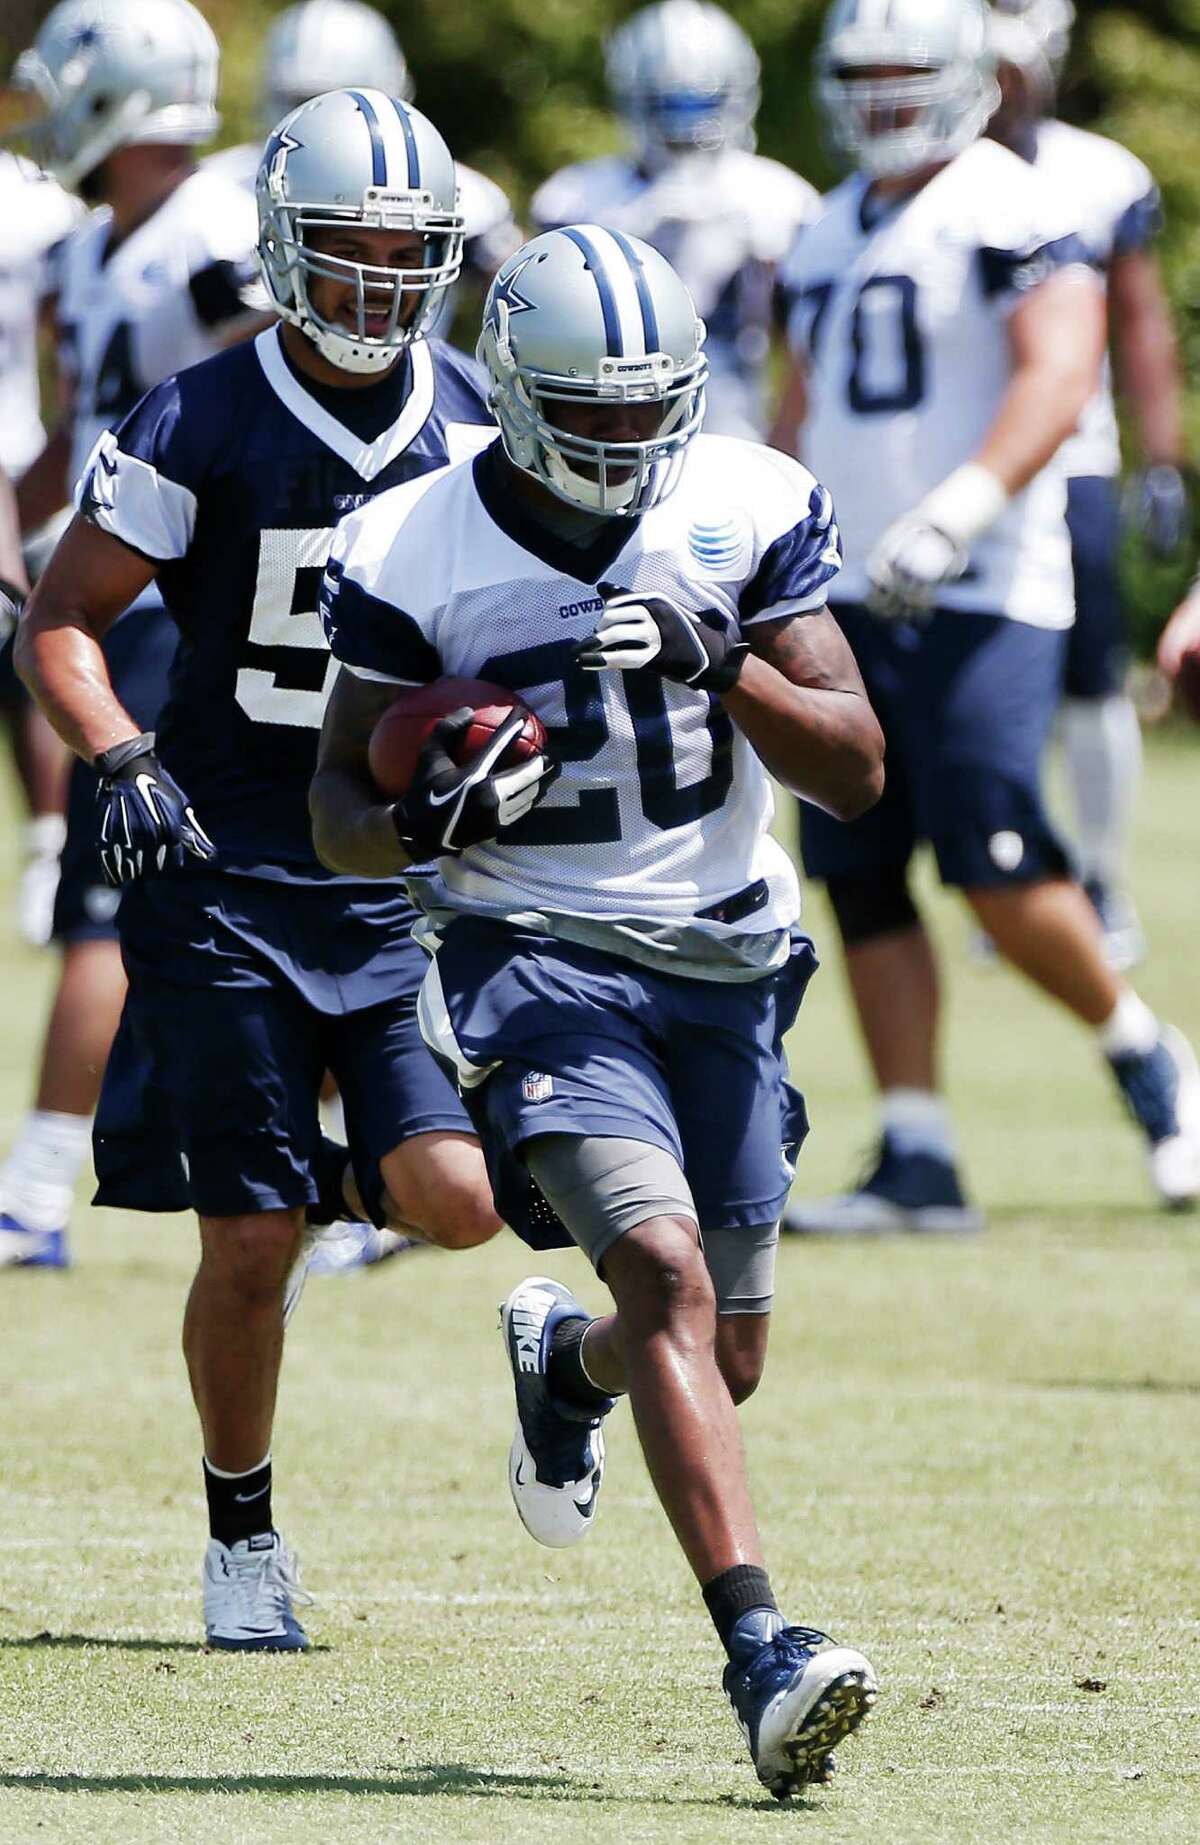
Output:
[96,732,216,886]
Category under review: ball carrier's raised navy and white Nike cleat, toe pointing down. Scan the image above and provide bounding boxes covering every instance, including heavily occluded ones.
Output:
[500,1275,615,1550]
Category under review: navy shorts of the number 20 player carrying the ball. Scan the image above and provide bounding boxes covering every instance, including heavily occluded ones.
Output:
[411,917,816,1249]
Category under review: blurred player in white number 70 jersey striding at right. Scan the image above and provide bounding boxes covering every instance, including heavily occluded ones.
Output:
[771,0,1200,1232]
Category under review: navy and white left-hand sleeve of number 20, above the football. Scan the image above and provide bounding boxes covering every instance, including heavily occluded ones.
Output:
[319,494,441,686]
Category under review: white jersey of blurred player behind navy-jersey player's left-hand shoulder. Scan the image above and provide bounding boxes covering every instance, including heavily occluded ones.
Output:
[57,168,266,480]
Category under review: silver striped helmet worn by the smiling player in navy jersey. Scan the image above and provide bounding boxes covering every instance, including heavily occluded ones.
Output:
[255,90,463,373]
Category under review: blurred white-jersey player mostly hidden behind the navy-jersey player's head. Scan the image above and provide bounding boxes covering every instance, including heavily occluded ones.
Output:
[205,0,521,309]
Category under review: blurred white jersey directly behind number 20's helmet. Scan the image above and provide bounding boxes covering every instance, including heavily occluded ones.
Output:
[530,148,818,437]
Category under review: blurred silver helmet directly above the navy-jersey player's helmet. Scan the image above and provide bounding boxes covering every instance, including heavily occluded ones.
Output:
[262,0,414,127]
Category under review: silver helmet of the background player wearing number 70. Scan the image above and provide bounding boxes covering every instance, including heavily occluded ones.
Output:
[816,0,999,179]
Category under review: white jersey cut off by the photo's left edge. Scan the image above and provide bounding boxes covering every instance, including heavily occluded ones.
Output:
[0,153,83,474]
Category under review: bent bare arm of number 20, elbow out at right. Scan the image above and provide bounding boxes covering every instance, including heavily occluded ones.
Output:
[724,609,882,819]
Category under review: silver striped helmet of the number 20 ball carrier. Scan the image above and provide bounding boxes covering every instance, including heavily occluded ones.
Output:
[478,225,709,517]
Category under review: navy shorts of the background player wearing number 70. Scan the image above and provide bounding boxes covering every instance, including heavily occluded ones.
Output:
[801,605,1069,889]
